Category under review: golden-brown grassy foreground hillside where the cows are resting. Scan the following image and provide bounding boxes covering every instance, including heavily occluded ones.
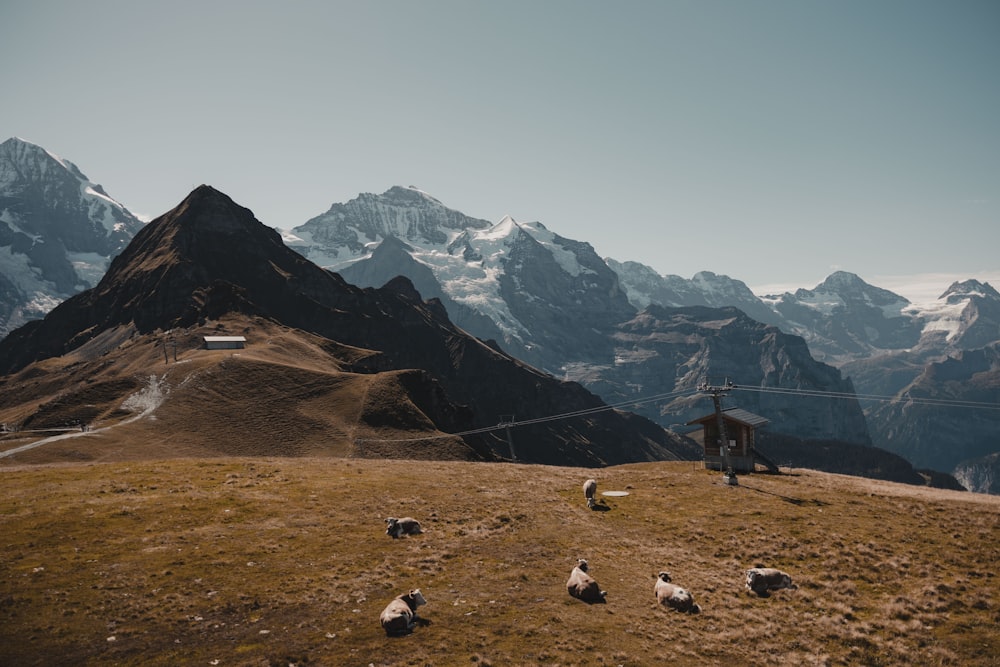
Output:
[0,458,1000,666]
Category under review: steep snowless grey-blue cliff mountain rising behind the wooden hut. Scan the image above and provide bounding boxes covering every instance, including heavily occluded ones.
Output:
[574,306,871,445]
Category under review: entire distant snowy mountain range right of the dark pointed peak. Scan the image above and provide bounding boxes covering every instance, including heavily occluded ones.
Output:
[4,140,1000,490]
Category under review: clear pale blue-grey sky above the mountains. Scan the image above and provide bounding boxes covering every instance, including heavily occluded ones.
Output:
[0,0,1000,302]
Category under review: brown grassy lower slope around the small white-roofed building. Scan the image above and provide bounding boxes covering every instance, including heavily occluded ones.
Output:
[0,317,480,466]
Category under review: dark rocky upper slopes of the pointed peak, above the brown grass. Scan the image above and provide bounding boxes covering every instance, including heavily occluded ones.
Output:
[0,186,690,466]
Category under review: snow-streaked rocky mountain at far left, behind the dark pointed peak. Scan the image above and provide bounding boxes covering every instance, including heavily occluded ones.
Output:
[0,138,143,336]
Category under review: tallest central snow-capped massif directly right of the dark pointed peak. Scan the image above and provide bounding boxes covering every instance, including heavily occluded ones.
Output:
[285,186,635,373]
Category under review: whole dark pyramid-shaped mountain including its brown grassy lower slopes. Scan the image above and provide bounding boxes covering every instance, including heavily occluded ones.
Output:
[0,186,697,466]
